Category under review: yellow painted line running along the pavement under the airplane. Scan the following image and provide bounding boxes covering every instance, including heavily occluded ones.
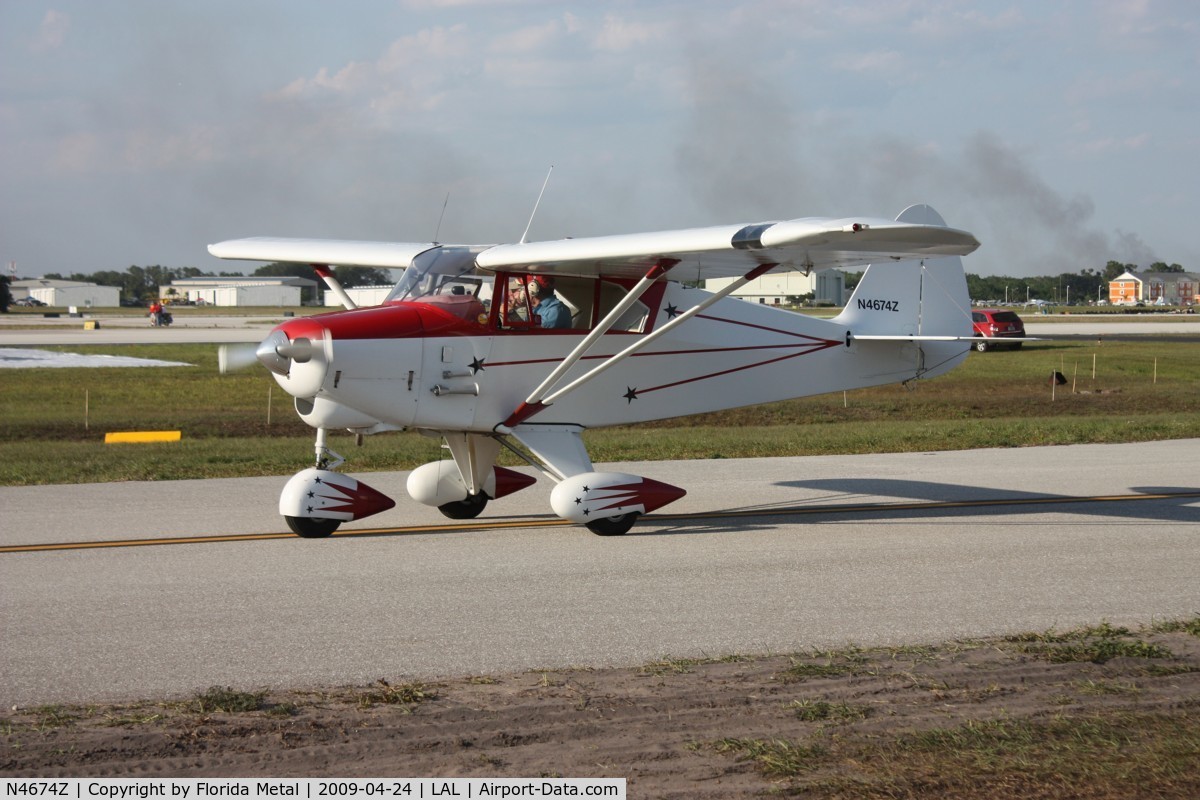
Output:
[0,491,1200,554]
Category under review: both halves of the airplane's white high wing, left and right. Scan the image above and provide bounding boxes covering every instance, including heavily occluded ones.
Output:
[209,217,979,279]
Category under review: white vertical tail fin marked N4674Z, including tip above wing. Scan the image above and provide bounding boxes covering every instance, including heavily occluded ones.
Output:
[833,205,972,337]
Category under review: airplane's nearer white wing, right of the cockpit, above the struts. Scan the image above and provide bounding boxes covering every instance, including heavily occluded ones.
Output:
[475,217,979,279]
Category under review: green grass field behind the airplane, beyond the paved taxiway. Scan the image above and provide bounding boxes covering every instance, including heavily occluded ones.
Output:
[0,337,1200,486]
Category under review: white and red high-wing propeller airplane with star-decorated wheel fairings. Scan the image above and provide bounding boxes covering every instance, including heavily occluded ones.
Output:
[216,205,979,537]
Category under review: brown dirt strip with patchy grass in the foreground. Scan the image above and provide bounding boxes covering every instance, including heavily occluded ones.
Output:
[0,618,1200,800]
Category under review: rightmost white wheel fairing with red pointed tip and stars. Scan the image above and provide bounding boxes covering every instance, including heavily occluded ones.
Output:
[550,473,688,524]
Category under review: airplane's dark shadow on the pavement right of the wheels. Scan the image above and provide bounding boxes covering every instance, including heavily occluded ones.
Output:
[629,479,1200,536]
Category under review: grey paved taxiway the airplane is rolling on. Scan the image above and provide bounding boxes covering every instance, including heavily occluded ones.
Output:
[0,440,1200,705]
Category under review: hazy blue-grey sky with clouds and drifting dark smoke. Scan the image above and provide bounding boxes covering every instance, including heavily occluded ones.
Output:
[0,0,1200,277]
